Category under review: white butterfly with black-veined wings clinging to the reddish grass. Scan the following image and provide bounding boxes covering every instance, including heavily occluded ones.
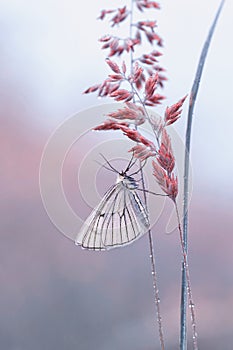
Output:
[75,158,150,250]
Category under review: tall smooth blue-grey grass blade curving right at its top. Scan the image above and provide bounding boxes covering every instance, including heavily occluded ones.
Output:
[180,0,224,350]
